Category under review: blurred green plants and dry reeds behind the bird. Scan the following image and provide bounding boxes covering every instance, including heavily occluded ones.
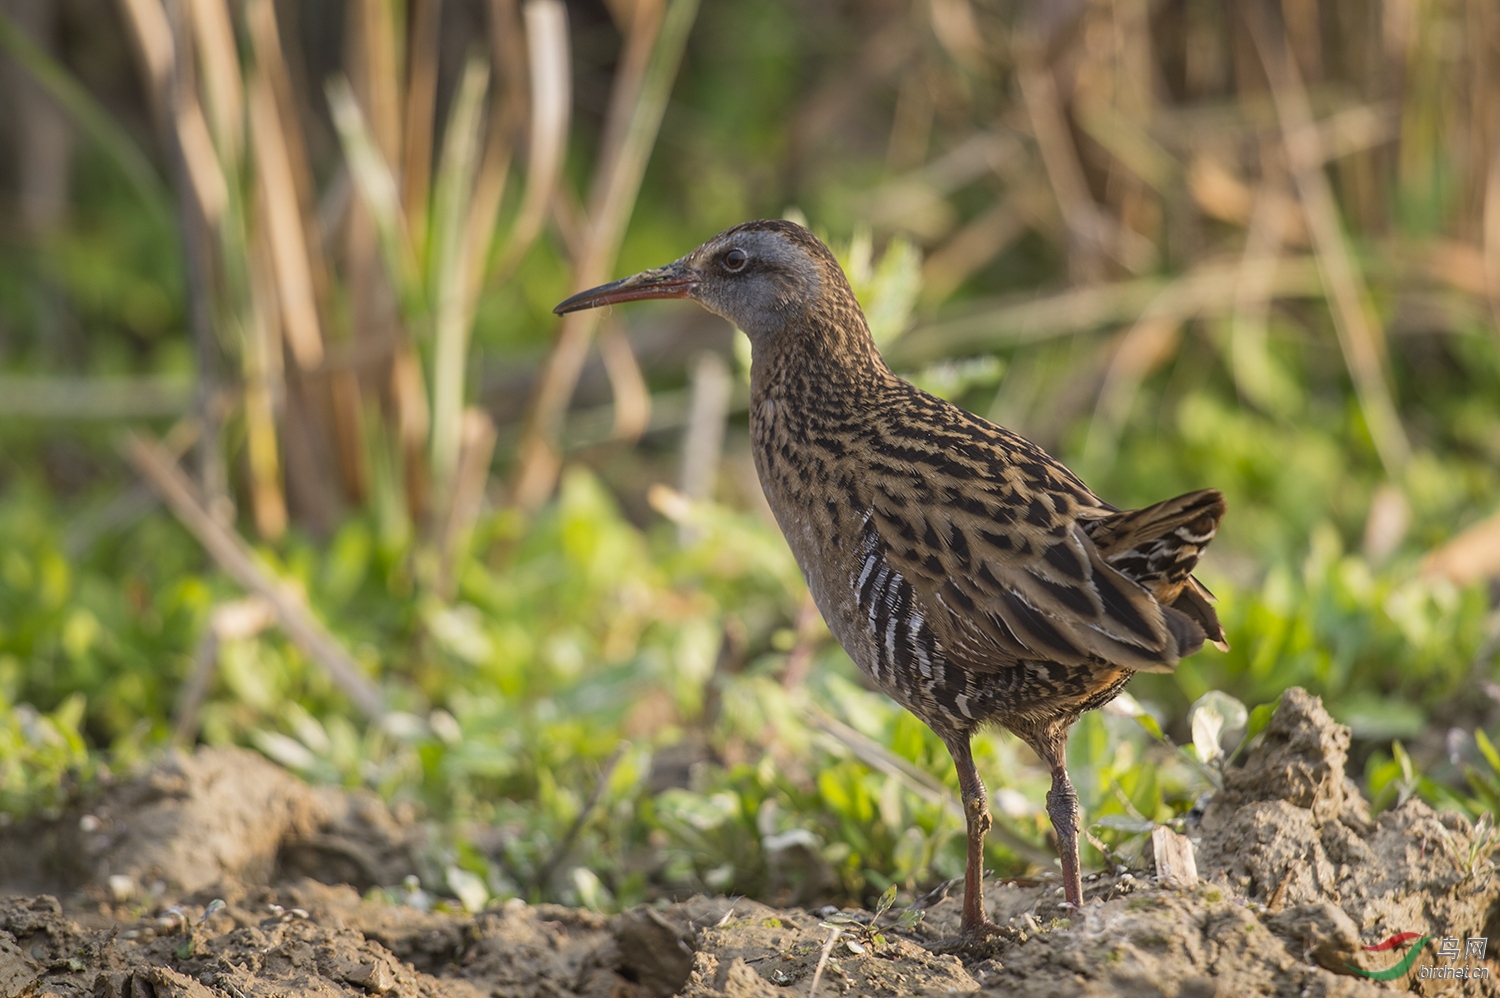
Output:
[0,0,1500,908]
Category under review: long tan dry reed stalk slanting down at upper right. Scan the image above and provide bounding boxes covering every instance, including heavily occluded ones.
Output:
[1248,7,1412,479]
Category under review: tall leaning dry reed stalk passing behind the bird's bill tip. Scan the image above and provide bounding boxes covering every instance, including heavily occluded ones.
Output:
[510,0,698,509]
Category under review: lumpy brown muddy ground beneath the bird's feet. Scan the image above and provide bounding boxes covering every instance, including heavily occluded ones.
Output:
[0,690,1500,998]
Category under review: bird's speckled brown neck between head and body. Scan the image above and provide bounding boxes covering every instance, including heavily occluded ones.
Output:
[750,293,896,408]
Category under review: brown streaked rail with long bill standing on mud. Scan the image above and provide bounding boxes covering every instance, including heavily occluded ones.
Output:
[554,219,1229,939]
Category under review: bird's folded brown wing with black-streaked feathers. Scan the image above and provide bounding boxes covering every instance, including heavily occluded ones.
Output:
[864,477,1218,672]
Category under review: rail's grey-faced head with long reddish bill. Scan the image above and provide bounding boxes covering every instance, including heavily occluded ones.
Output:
[552,219,854,342]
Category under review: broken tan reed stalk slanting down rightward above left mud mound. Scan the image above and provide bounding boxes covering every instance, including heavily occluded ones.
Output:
[125,434,386,720]
